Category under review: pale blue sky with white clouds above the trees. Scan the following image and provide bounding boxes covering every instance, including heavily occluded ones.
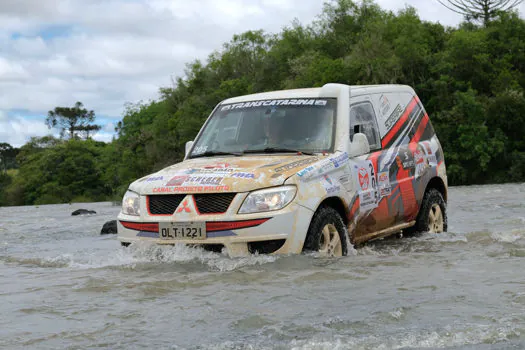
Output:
[0,0,525,147]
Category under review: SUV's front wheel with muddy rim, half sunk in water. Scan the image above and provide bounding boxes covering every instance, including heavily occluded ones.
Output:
[303,206,348,256]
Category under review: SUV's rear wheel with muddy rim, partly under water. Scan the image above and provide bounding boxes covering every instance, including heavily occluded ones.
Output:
[408,188,447,233]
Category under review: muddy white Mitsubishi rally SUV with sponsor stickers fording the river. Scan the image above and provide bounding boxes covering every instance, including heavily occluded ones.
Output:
[118,84,447,256]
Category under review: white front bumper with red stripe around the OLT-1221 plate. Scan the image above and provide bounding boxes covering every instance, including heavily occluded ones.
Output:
[117,203,313,256]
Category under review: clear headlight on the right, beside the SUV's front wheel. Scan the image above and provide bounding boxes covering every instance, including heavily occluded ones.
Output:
[239,186,297,214]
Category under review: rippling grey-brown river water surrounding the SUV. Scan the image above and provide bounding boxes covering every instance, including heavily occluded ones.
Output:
[0,184,525,349]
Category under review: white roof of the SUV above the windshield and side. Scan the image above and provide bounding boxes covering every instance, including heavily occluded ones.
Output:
[222,84,414,103]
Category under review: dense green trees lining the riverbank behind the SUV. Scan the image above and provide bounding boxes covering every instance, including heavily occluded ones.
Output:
[0,0,525,205]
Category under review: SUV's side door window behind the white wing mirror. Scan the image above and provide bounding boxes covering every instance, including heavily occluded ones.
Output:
[350,102,381,151]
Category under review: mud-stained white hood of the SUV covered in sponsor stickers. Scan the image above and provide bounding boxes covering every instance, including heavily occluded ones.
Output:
[130,155,324,195]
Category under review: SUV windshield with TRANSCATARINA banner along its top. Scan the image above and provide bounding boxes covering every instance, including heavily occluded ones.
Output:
[190,98,336,158]
